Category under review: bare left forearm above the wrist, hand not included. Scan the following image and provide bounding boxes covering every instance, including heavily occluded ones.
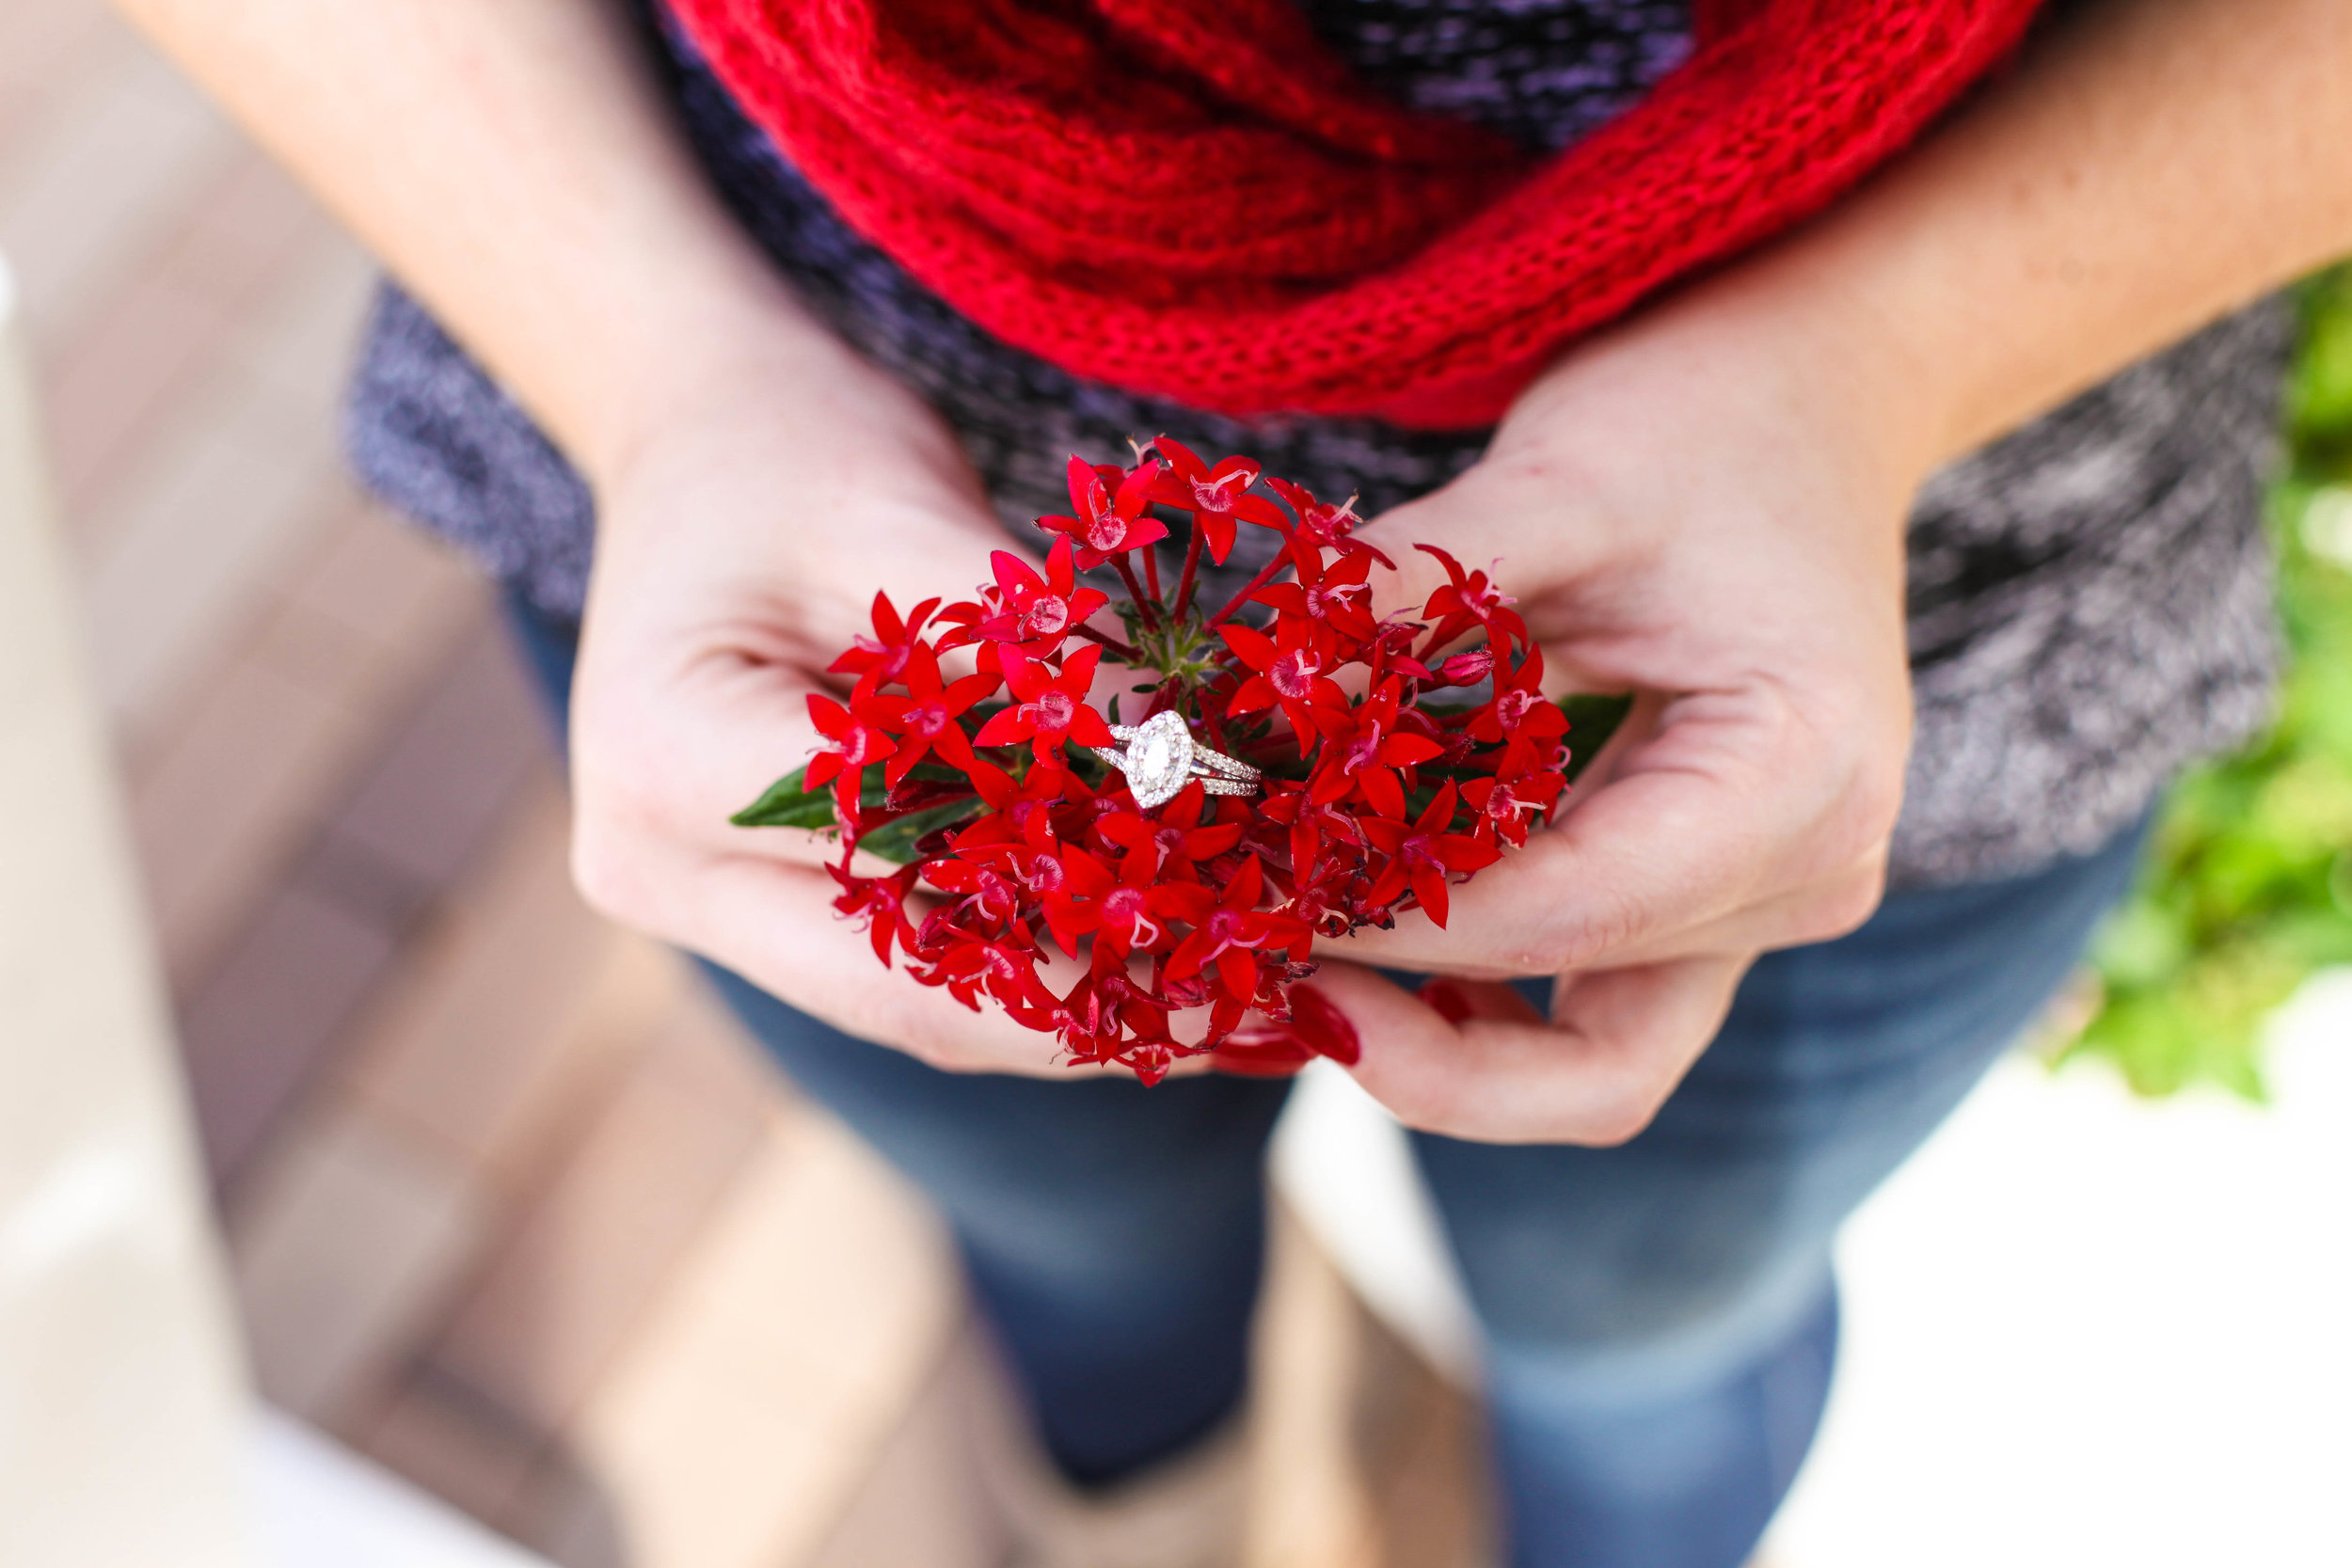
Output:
[120,0,845,477]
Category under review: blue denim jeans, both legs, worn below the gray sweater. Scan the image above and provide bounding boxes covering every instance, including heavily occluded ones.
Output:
[517,611,2143,1568]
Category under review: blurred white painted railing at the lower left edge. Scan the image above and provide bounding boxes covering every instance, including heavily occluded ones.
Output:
[0,261,546,1568]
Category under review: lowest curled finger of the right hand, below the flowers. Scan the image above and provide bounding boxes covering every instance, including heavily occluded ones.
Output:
[1315,957,1750,1145]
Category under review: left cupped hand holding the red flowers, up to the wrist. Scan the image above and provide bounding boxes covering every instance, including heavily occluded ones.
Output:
[572,353,1157,1077]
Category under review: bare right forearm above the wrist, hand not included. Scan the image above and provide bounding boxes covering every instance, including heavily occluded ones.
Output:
[1562,0,2352,482]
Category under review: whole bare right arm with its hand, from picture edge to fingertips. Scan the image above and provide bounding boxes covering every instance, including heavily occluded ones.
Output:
[1289,0,2352,1143]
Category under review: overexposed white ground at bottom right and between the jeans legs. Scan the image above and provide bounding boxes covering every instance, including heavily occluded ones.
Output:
[1275,974,2352,1568]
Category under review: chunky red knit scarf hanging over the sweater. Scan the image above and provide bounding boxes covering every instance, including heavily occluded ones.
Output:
[673,0,2037,428]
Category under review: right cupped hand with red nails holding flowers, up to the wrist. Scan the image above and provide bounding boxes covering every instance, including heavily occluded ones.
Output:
[1317,291,1919,1143]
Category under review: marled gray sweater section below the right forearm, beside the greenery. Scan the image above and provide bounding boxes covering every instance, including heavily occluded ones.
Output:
[1896,301,2294,881]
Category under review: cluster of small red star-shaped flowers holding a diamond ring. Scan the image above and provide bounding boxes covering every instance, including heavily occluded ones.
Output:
[734,437,1626,1084]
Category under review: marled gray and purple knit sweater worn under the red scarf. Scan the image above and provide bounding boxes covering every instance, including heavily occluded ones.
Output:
[348,0,2291,886]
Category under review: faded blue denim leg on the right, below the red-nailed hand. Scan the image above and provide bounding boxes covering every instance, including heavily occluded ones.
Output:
[1458,820,2145,1568]
